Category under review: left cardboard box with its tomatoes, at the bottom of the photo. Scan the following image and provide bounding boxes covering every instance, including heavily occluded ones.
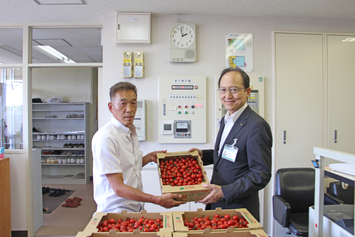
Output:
[82,210,174,236]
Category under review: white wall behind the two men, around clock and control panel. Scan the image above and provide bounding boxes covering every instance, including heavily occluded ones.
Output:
[99,13,355,234]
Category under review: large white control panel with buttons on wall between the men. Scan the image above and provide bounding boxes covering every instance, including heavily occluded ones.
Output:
[158,76,207,143]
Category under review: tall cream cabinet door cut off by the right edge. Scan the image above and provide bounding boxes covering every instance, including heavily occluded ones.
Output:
[327,35,355,154]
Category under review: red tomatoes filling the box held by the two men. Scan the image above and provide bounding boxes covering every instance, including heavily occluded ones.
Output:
[159,157,203,186]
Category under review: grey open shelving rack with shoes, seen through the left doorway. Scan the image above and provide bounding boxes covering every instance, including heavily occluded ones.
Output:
[32,103,91,184]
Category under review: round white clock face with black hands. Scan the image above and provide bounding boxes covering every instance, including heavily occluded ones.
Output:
[170,24,195,48]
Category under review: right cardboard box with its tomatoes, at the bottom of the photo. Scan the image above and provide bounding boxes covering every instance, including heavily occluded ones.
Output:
[173,208,263,233]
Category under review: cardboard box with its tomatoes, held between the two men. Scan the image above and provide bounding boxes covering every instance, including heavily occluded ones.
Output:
[157,151,211,202]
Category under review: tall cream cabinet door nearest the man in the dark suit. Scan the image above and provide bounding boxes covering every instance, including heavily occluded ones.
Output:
[274,33,323,170]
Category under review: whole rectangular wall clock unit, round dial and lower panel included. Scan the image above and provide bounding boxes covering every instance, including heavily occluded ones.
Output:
[169,23,196,63]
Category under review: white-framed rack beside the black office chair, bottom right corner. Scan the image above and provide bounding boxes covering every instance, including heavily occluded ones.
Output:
[309,147,355,237]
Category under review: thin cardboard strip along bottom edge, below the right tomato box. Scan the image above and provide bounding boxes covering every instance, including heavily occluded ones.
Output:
[173,229,268,237]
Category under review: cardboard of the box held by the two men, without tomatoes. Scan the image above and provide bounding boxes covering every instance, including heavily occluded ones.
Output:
[157,151,211,202]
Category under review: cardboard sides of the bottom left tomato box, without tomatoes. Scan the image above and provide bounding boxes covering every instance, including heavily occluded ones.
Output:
[82,210,174,234]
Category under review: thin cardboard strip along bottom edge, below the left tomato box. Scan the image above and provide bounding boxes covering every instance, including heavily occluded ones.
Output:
[75,231,173,237]
